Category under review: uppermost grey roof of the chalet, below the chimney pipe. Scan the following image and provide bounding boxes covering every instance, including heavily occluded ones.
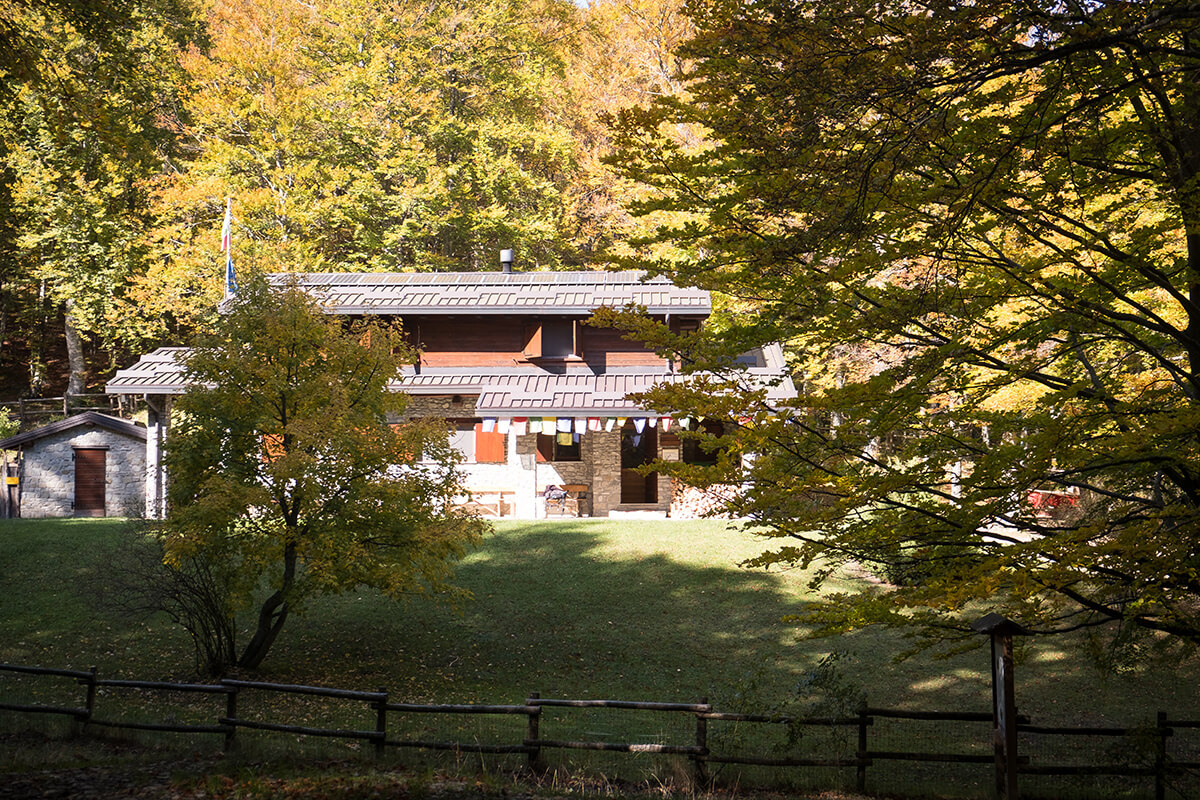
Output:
[262,271,713,317]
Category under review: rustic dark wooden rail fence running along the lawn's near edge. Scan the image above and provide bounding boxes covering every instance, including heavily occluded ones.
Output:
[0,664,1200,800]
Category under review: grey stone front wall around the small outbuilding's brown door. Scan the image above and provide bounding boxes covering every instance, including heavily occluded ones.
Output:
[20,426,146,517]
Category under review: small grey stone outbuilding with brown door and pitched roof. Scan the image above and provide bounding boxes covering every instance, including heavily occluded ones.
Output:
[0,411,146,517]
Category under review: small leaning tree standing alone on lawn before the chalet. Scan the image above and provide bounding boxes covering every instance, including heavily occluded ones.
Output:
[164,281,484,668]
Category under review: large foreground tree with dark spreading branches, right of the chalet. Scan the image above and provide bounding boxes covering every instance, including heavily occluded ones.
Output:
[619,0,1200,643]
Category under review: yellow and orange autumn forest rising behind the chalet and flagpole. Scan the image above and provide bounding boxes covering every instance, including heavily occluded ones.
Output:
[0,0,694,399]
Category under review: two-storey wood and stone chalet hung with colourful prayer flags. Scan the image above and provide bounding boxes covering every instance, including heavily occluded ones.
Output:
[107,272,794,519]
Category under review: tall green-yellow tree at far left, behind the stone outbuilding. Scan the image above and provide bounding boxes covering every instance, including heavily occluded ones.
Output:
[0,0,196,393]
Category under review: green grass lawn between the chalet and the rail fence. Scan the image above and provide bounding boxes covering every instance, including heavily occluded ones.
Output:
[0,519,1200,796]
